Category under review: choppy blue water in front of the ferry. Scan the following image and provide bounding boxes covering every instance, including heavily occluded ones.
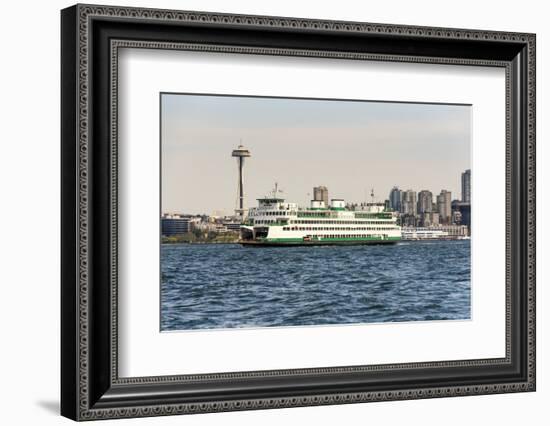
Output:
[161,241,470,331]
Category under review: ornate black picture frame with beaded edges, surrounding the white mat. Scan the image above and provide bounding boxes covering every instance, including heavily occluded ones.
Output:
[61,5,535,420]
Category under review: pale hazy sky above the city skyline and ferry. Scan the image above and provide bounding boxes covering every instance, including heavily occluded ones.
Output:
[161,94,472,215]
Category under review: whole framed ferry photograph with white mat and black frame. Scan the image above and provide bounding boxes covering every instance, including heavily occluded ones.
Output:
[61,5,535,420]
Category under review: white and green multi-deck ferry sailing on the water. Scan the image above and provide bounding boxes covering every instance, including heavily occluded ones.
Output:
[239,196,401,246]
